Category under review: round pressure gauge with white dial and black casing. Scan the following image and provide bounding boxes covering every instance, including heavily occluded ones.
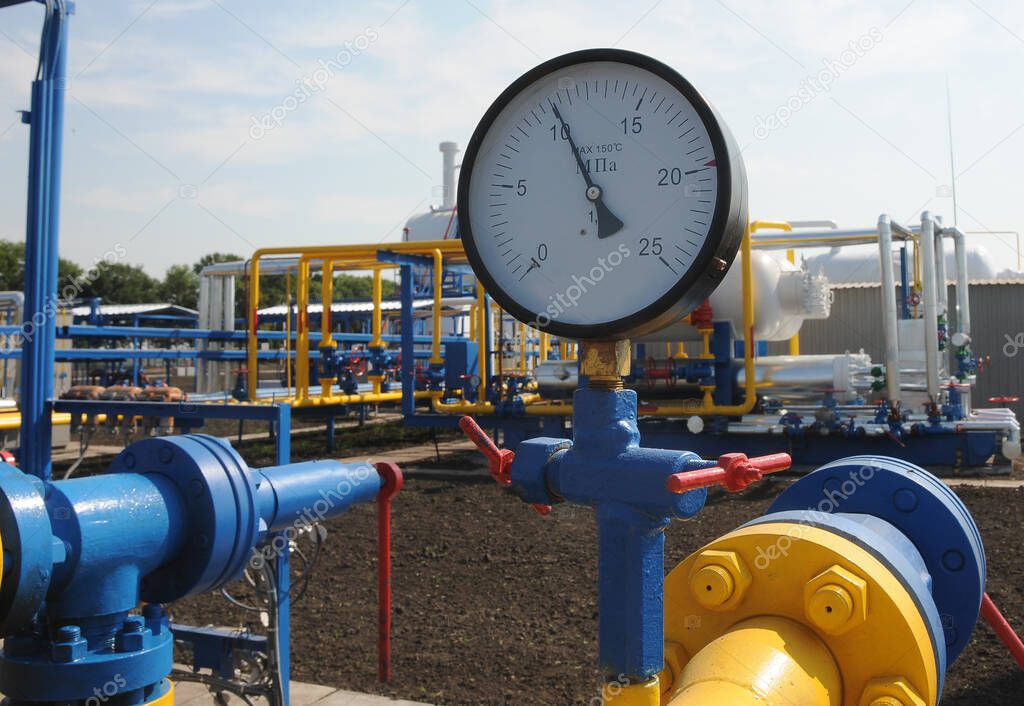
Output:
[458,49,748,339]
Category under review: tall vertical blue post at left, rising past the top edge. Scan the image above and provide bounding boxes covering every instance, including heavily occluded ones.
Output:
[18,0,71,480]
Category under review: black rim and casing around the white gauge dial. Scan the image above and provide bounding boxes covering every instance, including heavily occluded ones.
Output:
[458,48,748,339]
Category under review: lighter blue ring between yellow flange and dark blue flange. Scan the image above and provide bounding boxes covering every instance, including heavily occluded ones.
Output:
[743,509,948,694]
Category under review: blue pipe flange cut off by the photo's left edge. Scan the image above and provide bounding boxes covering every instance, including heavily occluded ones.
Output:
[0,463,54,635]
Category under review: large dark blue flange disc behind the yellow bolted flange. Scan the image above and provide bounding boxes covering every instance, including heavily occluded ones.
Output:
[768,456,986,664]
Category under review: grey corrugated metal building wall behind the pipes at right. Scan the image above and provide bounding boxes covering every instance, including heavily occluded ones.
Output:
[768,282,1024,418]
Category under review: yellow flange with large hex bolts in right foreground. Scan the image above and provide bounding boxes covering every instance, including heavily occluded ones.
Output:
[664,523,938,706]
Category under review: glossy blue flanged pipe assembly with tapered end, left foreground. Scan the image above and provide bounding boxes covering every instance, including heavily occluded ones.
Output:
[0,434,383,706]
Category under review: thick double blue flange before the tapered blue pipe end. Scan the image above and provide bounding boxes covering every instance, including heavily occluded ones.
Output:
[108,434,259,604]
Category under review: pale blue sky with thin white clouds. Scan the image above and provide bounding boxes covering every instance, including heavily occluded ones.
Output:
[0,0,1024,277]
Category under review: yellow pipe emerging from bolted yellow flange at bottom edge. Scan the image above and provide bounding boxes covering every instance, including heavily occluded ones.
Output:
[667,617,843,706]
